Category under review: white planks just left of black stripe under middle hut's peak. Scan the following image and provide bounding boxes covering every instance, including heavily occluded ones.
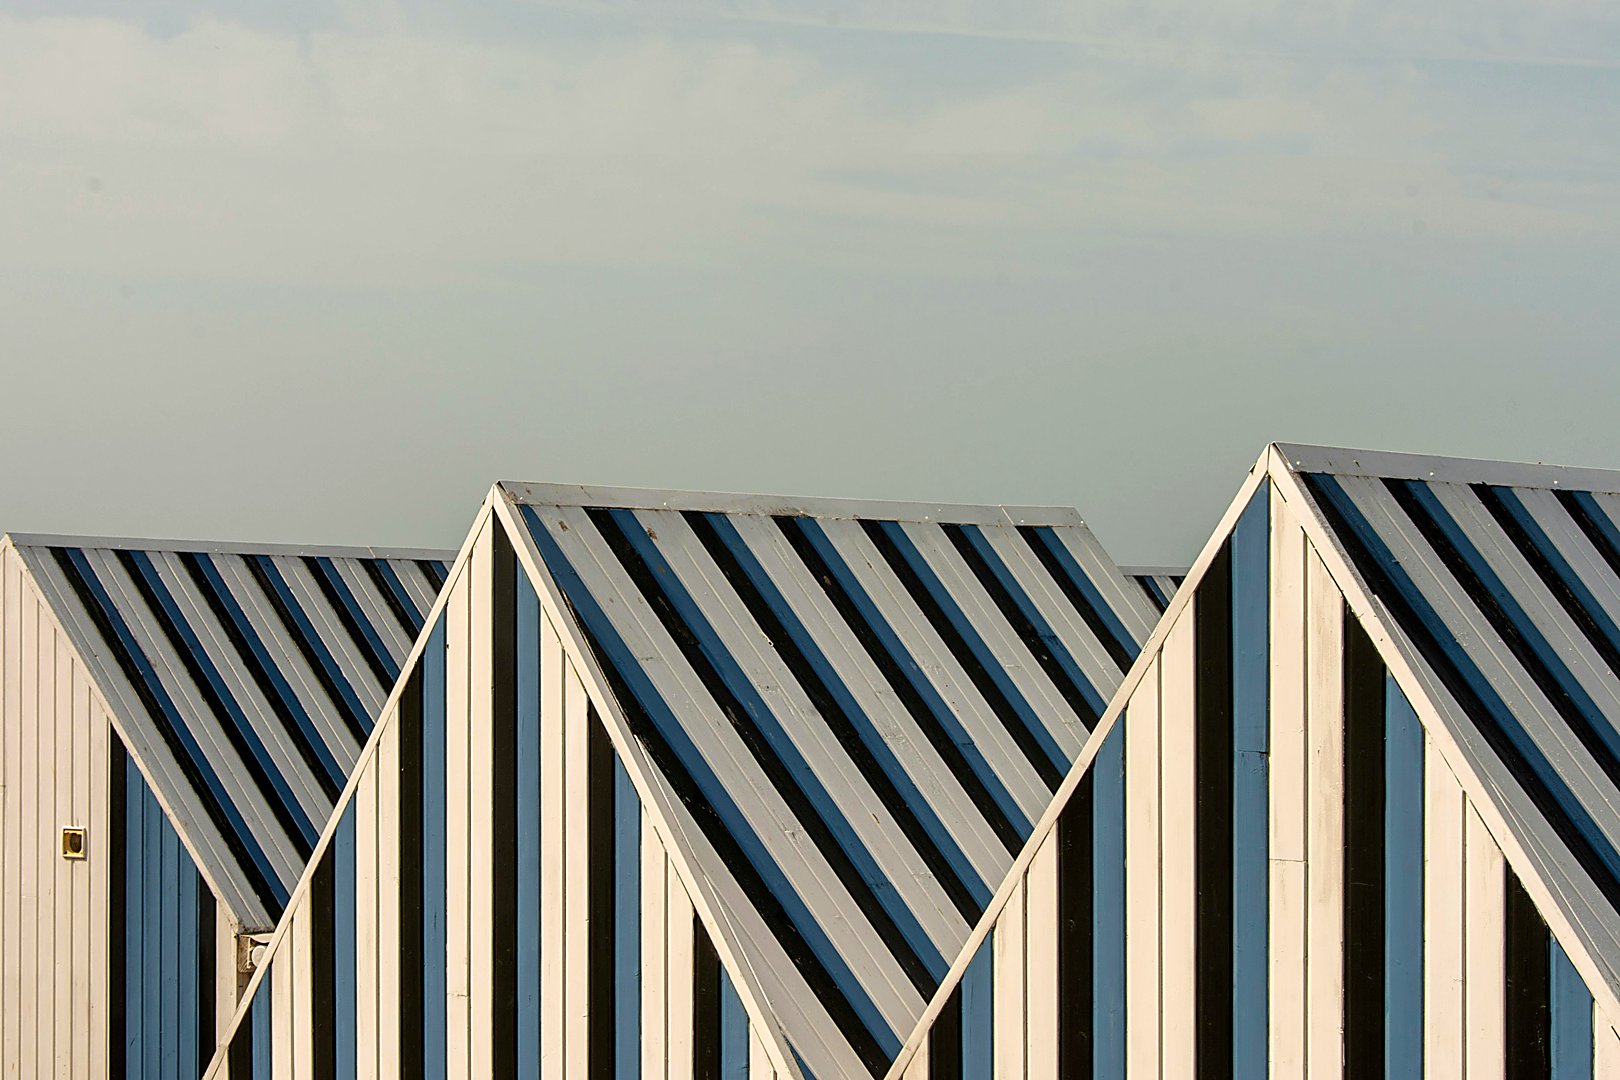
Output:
[444,544,473,1080]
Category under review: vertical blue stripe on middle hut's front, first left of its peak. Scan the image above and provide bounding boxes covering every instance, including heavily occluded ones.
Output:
[421,619,449,1080]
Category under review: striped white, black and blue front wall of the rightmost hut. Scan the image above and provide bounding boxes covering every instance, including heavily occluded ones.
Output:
[891,469,1620,1080]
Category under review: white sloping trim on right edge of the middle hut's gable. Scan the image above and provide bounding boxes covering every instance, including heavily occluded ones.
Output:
[486,484,804,1080]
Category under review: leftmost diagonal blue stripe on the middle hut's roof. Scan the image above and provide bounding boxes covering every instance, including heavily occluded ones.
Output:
[522,505,901,1056]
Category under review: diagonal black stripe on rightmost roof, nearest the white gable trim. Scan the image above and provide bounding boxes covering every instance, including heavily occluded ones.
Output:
[1304,473,1620,908]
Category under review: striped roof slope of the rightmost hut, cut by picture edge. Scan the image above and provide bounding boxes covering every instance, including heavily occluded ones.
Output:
[1278,447,1620,1003]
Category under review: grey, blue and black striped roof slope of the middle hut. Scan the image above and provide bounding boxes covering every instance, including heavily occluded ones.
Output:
[502,484,1157,1075]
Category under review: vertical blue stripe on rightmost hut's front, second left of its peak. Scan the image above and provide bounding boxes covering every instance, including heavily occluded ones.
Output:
[1092,719,1126,1078]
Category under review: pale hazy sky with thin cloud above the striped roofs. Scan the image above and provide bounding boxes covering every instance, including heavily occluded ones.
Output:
[0,0,1620,563]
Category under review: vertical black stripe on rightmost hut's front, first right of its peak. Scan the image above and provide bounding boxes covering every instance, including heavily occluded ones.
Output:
[1340,612,1385,1080]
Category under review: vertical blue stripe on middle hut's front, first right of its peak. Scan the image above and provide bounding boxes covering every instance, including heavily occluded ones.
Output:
[517,573,541,1080]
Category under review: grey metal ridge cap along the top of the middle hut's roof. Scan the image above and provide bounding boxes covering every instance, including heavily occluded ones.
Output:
[496,481,1085,525]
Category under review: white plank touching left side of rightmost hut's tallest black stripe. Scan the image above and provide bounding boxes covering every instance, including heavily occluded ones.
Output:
[1159,612,1197,1078]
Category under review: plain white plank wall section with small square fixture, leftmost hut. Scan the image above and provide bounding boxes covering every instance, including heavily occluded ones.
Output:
[0,544,112,1077]
